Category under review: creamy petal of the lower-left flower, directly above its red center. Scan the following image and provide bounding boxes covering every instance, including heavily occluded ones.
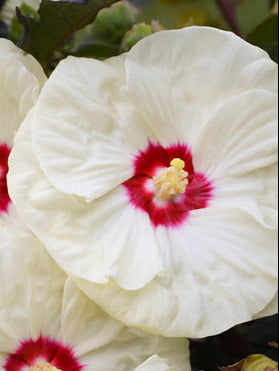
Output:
[0,237,65,353]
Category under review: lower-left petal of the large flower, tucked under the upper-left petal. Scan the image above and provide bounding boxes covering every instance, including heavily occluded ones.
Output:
[8,113,162,289]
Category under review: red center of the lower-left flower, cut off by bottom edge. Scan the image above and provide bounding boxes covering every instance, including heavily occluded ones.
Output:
[4,336,83,371]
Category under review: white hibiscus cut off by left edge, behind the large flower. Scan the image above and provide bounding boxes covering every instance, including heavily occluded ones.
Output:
[0,39,46,243]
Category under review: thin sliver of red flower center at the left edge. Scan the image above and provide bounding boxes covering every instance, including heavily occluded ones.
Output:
[0,143,11,214]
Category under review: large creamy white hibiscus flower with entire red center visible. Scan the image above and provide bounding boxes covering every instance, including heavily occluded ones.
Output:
[9,27,277,337]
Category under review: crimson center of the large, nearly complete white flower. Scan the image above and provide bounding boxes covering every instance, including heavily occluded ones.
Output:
[123,143,213,227]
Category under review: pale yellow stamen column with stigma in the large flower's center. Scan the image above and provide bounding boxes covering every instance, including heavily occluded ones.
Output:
[153,158,188,200]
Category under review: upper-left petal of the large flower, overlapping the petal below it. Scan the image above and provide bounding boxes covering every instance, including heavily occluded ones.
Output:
[32,57,155,201]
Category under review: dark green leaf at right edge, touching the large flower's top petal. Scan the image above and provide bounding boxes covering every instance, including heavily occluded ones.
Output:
[247,14,278,62]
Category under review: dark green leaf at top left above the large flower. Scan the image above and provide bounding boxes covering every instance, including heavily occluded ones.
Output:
[17,0,117,65]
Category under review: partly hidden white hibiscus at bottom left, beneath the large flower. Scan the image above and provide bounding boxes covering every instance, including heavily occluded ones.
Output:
[0,237,191,371]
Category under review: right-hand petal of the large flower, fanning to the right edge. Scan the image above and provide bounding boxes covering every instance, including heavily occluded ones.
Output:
[192,90,278,228]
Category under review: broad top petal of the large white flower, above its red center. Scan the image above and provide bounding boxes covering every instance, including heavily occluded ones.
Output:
[123,27,278,145]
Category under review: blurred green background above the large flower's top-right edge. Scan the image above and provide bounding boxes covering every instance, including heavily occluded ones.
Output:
[131,0,278,62]
